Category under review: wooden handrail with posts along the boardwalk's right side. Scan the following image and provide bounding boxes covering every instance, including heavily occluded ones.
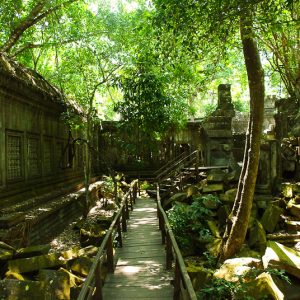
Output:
[156,184,197,300]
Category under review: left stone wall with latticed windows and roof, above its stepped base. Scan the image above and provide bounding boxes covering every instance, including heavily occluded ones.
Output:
[0,56,82,203]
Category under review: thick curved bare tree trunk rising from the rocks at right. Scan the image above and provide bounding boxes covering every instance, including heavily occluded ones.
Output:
[220,13,264,260]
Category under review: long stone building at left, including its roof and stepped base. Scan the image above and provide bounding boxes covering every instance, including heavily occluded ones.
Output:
[0,54,103,246]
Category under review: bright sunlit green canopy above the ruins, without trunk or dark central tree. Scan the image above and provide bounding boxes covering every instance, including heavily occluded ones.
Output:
[0,0,299,120]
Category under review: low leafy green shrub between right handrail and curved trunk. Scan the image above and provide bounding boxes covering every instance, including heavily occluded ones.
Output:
[167,194,220,250]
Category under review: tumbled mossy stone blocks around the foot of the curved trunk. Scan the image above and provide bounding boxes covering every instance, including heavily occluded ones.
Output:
[164,169,300,299]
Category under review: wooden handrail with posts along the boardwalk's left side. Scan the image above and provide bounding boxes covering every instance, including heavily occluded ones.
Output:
[77,180,138,300]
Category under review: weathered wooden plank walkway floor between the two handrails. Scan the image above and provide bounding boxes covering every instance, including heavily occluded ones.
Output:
[103,198,173,300]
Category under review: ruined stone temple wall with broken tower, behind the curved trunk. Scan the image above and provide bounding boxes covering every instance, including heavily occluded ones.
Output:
[99,84,300,193]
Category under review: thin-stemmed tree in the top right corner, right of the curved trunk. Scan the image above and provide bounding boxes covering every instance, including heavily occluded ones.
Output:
[259,1,300,101]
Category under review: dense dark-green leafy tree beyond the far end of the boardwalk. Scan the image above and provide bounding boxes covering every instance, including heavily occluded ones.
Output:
[115,57,179,160]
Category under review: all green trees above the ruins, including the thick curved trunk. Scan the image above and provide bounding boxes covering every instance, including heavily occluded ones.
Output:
[0,0,300,259]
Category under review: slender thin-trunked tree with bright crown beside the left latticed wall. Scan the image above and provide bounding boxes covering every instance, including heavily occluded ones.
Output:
[52,42,120,216]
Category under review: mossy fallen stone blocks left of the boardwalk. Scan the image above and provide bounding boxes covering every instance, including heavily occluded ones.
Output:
[0,201,117,299]
